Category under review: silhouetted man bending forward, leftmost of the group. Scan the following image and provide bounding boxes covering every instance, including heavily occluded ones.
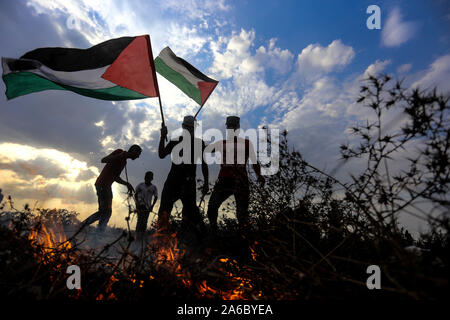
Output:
[80,144,142,233]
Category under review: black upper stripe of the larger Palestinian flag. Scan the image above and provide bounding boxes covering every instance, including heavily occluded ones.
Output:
[21,37,135,71]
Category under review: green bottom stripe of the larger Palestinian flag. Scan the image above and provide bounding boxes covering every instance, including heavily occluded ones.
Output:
[3,72,148,100]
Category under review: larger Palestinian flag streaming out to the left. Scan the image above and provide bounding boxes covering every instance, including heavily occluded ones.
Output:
[2,35,159,100]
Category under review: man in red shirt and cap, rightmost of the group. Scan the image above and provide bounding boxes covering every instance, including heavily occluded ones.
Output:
[208,116,264,230]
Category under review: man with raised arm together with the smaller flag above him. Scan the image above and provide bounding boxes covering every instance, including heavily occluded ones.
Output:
[155,47,219,233]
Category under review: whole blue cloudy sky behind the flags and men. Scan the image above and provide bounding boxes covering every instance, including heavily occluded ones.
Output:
[0,0,450,230]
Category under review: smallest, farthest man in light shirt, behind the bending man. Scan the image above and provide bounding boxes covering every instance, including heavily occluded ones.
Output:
[135,171,158,241]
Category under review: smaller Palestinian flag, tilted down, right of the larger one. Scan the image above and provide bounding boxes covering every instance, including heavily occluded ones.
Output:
[155,47,219,106]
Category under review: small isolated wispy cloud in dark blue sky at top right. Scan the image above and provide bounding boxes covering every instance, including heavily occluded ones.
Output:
[381,7,417,47]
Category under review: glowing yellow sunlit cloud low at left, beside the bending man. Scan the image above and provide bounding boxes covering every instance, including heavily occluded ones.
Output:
[0,143,98,210]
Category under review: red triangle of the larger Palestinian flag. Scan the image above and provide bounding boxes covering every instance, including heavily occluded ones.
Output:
[102,35,159,97]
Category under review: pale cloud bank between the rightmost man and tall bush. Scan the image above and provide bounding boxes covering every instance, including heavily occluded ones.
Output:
[272,60,390,169]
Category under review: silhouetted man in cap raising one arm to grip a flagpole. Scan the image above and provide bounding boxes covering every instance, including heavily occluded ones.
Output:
[158,116,208,230]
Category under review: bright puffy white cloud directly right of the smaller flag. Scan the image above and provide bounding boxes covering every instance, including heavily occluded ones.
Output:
[203,29,300,119]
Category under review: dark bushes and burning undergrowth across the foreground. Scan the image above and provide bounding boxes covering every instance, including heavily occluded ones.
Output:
[0,76,450,301]
